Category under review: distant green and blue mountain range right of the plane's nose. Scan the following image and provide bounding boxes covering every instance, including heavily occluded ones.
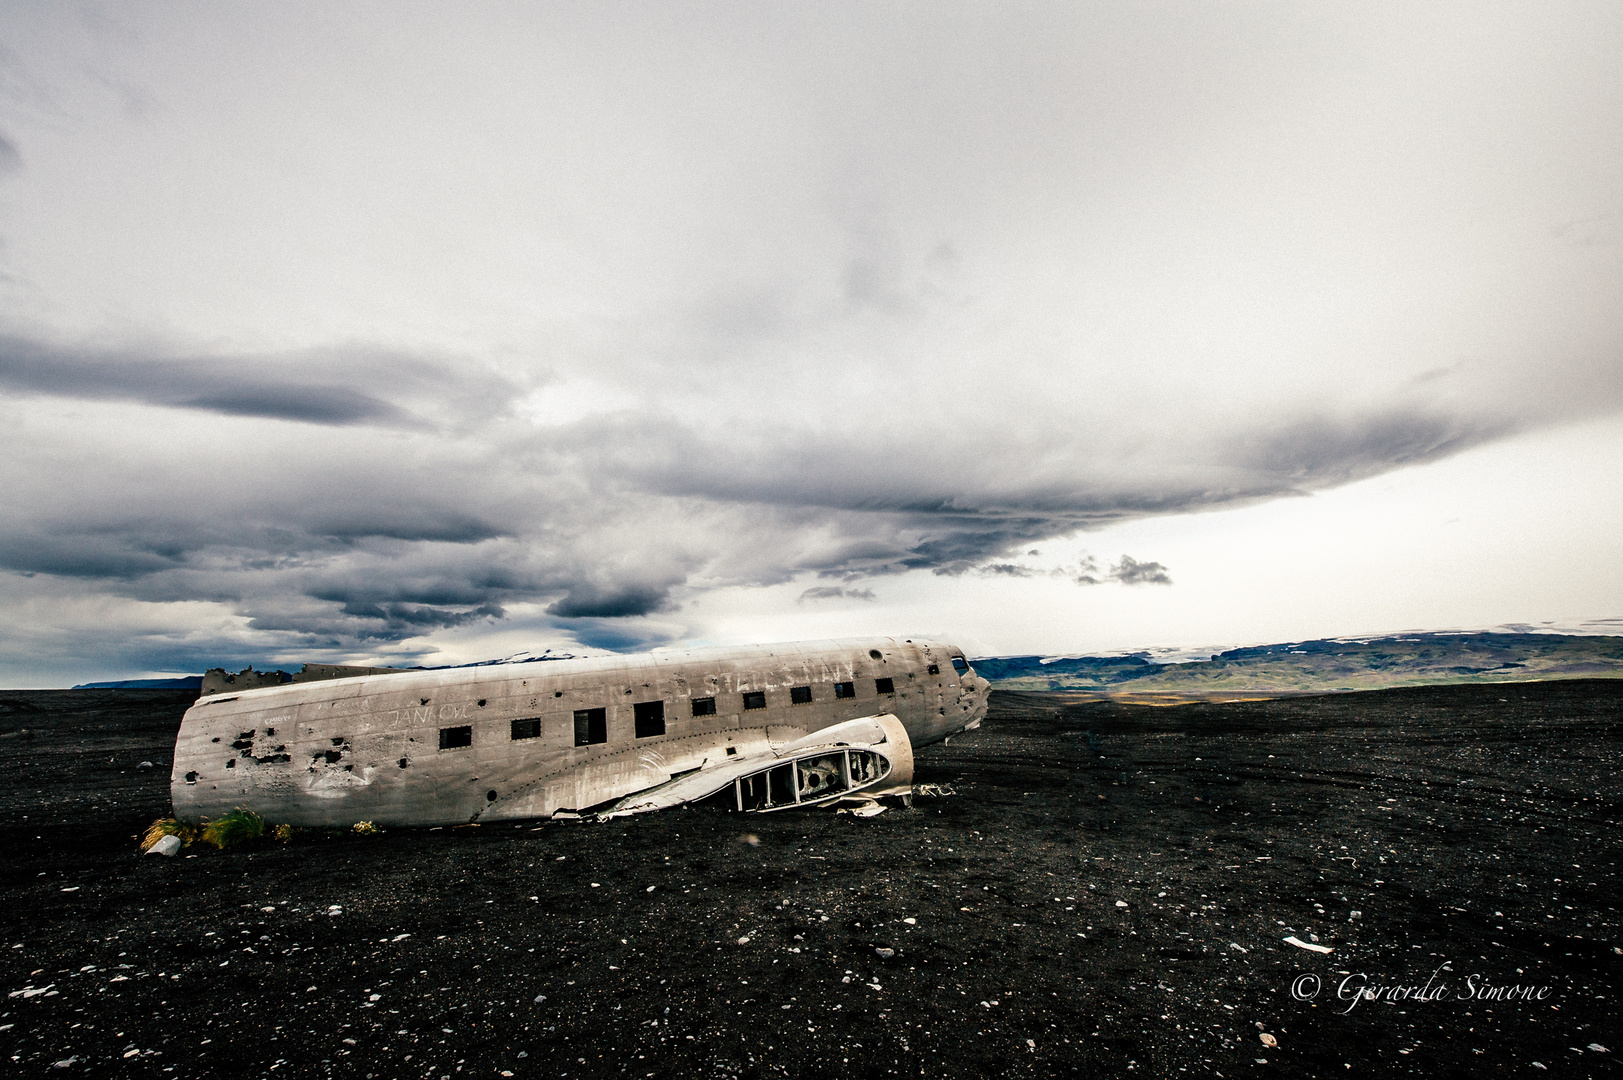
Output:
[971,633,1623,703]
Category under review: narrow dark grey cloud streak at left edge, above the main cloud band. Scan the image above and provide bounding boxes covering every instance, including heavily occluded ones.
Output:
[0,335,514,427]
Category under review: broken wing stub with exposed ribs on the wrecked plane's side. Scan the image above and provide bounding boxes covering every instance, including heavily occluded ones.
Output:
[599,713,912,817]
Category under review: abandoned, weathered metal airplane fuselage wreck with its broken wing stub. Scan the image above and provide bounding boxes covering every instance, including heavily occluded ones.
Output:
[170,638,990,827]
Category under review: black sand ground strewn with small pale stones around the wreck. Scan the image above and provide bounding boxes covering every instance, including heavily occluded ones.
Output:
[0,680,1623,1078]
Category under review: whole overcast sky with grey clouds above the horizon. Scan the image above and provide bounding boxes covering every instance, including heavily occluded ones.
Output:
[0,0,1623,685]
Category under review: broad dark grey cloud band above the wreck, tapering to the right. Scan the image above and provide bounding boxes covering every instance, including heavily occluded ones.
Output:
[0,383,1525,669]
